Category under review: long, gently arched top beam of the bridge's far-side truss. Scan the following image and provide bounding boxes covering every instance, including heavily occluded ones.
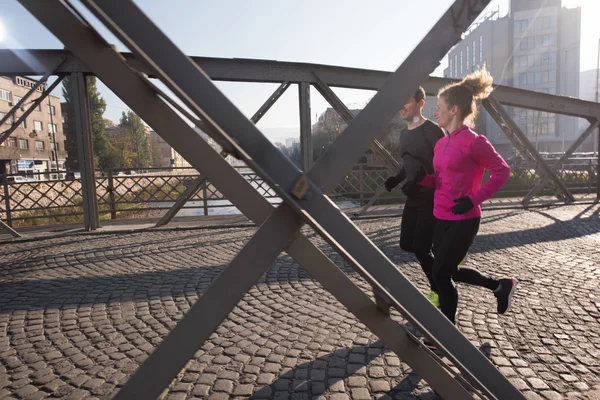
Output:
[0,49,600,118]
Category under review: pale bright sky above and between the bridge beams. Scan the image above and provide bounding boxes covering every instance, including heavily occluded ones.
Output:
[0,0,600,141]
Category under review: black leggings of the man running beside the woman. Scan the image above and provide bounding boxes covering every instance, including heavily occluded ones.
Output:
[400,202,437,292]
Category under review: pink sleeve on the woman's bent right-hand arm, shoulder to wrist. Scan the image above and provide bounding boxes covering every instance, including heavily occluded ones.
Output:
[469,136,510,205]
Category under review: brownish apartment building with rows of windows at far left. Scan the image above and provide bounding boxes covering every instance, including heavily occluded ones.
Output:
[0,76,67,180]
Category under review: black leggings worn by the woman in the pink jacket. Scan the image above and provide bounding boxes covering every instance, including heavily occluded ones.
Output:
[433,218,499,323]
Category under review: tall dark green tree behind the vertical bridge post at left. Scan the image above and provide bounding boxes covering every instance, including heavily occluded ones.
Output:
[62,76,115,170]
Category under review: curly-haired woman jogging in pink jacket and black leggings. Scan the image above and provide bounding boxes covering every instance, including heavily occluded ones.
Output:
[415,67,517,323]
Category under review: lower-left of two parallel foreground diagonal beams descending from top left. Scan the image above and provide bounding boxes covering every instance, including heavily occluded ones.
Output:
[16,0,482,399]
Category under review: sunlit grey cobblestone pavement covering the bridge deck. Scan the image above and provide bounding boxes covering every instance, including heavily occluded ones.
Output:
[0,205,600,400]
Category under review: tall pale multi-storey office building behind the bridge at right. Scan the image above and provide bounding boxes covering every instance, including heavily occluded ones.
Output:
[444,0,581,156]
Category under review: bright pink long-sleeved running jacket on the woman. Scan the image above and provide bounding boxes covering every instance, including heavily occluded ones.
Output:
[420,125,510,221]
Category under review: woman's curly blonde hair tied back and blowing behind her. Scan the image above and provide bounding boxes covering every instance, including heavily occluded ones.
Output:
[438,65,494,128]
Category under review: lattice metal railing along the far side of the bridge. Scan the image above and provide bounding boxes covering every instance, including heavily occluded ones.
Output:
[0,158,598,226]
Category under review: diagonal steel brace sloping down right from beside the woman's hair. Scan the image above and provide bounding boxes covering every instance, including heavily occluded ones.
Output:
[481,94,575,204]
